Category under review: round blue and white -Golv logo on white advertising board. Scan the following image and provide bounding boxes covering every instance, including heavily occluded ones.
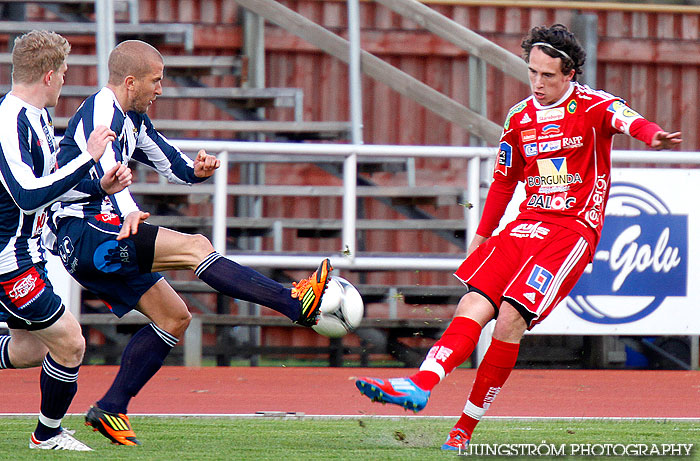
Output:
[565,183,689,325]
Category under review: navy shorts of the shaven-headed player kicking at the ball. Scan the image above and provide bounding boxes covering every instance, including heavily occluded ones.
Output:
[56,215,163,317]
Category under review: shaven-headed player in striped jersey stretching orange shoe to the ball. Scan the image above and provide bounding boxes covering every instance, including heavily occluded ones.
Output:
[49,40,332,445]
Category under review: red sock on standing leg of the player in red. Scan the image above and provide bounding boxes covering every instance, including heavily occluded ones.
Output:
[455,338,520,436]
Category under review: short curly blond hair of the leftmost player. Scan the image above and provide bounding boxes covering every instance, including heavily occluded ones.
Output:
[12,30,70,83]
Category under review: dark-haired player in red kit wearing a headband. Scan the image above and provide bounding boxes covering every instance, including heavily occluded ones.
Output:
[355,24,681,450]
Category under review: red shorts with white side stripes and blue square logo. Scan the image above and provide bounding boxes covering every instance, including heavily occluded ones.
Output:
[455,220,591,328]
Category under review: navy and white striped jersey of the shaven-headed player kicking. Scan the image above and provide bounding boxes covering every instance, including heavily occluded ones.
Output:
[50,87,206,226]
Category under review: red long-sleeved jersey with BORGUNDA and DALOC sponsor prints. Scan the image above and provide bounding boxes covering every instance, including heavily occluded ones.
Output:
[477,82,662,252]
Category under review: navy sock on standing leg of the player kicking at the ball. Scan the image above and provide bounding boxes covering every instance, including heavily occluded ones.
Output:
[97,323,178,414]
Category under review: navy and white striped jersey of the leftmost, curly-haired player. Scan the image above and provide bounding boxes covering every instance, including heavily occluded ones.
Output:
[0,93,101,274]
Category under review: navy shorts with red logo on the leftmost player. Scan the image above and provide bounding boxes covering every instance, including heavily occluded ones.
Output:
[0,262,65,330]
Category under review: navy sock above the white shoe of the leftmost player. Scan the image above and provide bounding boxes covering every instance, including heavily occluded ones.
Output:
[34,354,80,440]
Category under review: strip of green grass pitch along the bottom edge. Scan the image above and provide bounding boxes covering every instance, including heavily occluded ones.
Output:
[0,415,700,461]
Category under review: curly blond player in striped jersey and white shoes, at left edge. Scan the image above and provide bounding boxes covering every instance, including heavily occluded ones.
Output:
[0,31,131,452]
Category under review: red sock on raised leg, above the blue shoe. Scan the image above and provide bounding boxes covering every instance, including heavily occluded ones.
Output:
[410,317,481,391]
